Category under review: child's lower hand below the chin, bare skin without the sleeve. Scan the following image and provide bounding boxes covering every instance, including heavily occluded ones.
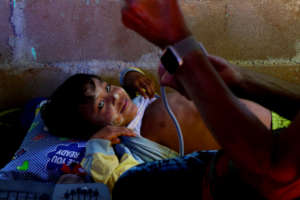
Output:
[91,126,136,144]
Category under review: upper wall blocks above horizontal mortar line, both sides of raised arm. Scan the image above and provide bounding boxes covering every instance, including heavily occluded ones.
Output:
[0,0,300,64]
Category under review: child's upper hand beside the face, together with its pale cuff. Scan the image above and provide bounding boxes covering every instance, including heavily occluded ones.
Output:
[120,67,155,98]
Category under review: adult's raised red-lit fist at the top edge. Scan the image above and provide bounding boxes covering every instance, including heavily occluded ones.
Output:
[122,0,191,49]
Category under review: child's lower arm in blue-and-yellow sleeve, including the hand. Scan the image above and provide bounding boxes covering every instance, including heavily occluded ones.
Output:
[81,126,139,190]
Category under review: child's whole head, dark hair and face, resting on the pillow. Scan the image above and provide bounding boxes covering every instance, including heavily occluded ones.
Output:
[42,74,137,139]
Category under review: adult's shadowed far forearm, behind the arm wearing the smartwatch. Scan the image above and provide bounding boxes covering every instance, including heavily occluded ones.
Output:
[233,67,300,119]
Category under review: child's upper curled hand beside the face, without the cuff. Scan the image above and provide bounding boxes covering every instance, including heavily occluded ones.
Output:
[124,71,155,98]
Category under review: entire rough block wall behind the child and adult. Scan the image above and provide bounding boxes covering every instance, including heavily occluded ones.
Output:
[0,0,300,109]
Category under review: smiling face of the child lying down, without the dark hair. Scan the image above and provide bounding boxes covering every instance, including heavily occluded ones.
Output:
[80,78,137,127]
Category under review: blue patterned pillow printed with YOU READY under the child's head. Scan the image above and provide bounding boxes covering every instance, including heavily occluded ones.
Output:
[0,101,86,182]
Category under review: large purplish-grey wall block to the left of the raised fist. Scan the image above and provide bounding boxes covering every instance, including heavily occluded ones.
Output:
[24,0,155,63]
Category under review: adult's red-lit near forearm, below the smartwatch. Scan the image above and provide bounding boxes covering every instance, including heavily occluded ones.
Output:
[176,52,273,173]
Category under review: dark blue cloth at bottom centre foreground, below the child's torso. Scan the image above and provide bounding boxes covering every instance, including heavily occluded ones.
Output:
[112,151,217,199]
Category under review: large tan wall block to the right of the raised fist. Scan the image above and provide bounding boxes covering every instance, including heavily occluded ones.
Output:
[182,0,300,64]
